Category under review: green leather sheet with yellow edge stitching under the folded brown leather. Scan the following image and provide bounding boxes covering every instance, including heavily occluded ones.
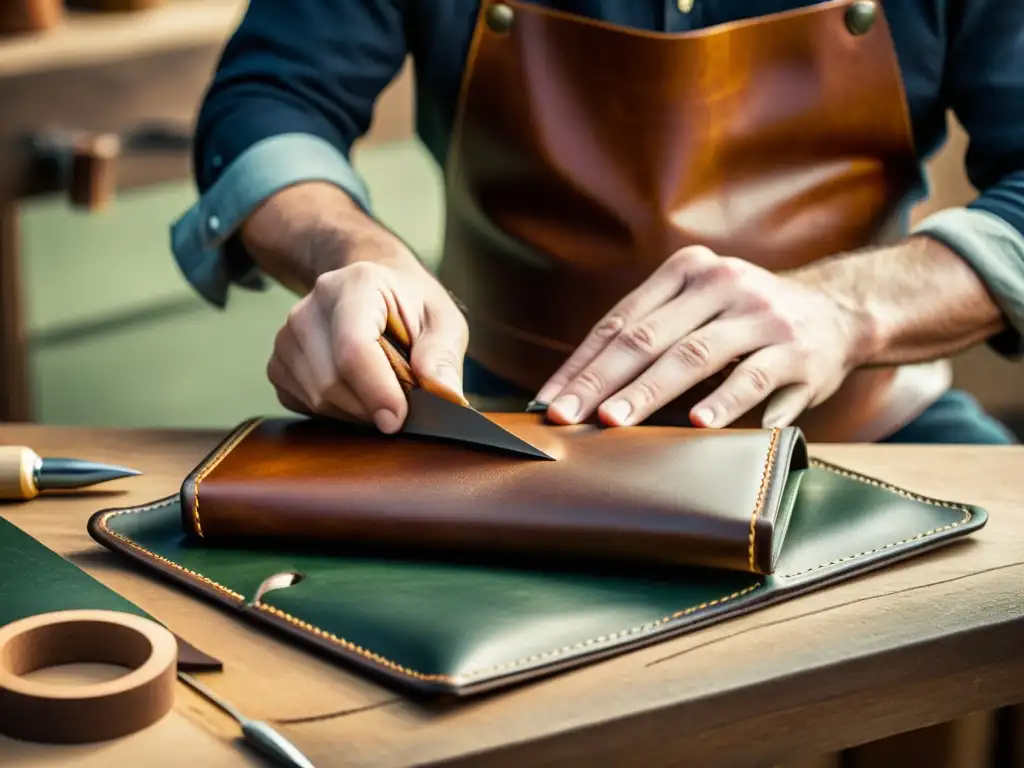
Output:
[89,462,986,695]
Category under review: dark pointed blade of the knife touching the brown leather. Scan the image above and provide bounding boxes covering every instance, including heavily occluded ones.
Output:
[402,388,554,461]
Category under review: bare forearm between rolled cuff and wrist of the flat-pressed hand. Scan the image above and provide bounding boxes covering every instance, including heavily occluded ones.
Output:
[791,237,1006,366]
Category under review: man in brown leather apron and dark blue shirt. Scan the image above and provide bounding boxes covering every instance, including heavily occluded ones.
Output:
[172,0,1024,443]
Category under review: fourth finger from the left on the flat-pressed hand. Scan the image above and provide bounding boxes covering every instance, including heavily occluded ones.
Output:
[690,345,801,427]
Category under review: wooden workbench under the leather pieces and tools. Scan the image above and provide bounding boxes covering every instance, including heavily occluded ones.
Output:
[0,426,1024,768]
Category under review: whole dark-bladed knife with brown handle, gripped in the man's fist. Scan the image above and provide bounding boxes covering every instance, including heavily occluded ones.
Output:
[380,313,554,461]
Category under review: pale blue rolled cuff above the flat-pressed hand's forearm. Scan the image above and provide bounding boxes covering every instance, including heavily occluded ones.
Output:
[913,208,1024,334]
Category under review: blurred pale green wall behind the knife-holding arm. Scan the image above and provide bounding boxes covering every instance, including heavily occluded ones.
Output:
[23,141,443,427]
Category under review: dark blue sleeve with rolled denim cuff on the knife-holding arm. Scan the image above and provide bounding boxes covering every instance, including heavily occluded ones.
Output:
[171,0,407,306]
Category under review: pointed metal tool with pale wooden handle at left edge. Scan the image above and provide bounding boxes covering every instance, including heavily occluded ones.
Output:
[0,445,142,501]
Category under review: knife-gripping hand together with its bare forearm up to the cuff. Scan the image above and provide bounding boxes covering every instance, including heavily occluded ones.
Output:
[244,184,468,432]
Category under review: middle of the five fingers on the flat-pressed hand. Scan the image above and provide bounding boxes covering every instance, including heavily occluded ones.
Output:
[598,317,769,427]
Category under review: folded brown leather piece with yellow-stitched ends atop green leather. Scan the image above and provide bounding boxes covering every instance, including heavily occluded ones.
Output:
[181,414,807,573]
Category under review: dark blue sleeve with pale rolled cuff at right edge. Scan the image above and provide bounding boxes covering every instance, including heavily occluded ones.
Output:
[916,0,1024,357]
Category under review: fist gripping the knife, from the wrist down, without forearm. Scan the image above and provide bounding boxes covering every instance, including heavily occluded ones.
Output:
[267,232,469,433]
